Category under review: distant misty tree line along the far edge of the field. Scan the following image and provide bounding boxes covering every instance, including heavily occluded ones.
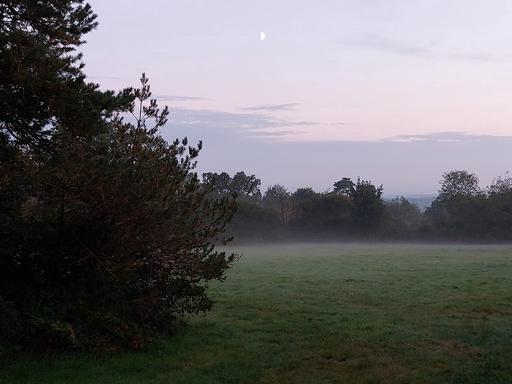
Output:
[203,171,512,241]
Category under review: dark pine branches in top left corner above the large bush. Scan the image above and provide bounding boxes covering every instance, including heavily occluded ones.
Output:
[0,0,130,148]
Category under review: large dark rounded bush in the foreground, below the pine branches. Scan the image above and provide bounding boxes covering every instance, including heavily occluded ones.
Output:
[0,76,236,351]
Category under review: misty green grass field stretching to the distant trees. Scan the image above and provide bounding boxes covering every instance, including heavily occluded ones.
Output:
[0,244,512,384]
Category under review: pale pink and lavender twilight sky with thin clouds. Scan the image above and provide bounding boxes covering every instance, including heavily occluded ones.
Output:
[81,0,512,196]
